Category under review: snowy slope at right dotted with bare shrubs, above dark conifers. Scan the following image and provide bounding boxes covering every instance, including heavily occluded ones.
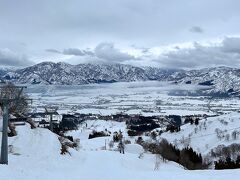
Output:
[161,112,240,158]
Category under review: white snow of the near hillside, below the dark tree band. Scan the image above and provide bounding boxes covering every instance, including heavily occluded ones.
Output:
[0,113,240,180]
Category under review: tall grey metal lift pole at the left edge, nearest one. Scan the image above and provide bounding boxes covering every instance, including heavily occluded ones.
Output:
[0,86,26,164]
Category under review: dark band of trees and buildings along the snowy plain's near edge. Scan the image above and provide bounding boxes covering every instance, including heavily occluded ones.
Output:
[9,104,208,133]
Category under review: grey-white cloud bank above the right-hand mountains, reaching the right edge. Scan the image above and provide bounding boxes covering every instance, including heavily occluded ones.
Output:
[153,37,240,69]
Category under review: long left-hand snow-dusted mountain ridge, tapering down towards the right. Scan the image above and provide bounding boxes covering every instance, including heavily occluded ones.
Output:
[1,62,176,85]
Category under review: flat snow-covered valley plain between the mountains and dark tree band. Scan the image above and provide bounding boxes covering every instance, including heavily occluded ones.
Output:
[27,81,240,115]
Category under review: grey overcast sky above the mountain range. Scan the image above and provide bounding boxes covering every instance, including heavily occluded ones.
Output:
[0,0,240,69]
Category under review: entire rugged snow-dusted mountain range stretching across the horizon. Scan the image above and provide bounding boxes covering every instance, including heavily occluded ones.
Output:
[0,62,240,93]
